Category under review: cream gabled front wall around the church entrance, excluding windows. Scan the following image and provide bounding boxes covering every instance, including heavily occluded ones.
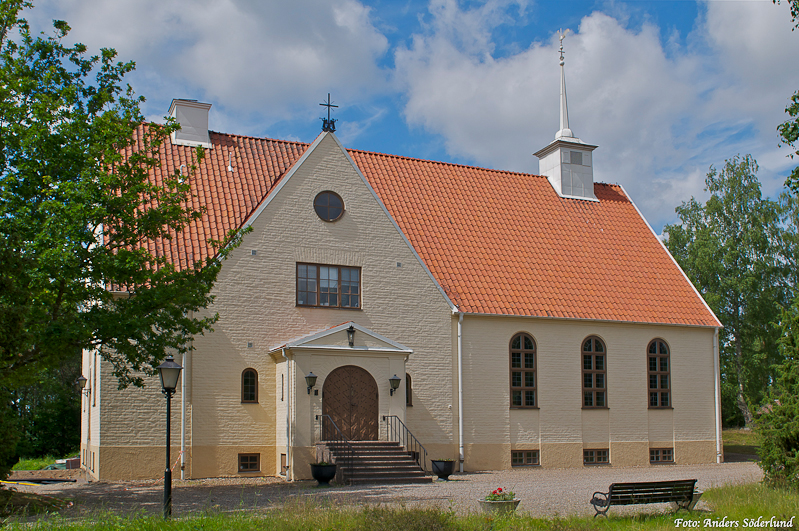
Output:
[186,135,453,477]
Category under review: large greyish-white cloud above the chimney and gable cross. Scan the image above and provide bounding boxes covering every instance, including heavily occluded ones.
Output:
[28,0,388,132]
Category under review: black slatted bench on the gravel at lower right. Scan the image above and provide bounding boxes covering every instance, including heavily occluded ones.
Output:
[591,479,699,518]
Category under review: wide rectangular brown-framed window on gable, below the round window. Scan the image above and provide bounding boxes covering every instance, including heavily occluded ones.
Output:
[297,263,361,308]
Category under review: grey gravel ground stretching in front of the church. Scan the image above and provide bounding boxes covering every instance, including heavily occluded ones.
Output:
[10,462,762,517]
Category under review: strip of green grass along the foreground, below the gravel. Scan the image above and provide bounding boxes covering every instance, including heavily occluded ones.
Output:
[0,484,799,531]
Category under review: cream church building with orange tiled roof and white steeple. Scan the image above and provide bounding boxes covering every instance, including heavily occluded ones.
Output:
[81,42,723,480]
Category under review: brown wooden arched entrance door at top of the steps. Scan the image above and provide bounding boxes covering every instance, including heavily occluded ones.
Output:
[322,365,378,441]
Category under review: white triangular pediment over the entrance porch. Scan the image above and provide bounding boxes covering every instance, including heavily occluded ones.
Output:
[270,321,413,357]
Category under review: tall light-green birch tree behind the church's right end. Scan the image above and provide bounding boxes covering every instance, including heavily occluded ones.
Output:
[664,155,789,426]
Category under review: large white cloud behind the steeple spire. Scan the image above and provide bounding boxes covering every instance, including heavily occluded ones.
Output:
[395,0,799,230]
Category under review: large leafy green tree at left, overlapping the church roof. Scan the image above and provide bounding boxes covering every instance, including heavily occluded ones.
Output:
[0,0,240,478]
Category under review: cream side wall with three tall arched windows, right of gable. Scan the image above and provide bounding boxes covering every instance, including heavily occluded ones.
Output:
[453,315,715,470]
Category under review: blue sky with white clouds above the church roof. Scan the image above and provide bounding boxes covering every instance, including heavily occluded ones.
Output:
[26,0,799,233]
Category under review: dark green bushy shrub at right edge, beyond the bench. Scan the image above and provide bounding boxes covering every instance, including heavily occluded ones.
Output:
[757,302,799,490]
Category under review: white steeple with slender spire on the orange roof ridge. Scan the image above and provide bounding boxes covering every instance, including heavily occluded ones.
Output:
[535,33,597,201]
